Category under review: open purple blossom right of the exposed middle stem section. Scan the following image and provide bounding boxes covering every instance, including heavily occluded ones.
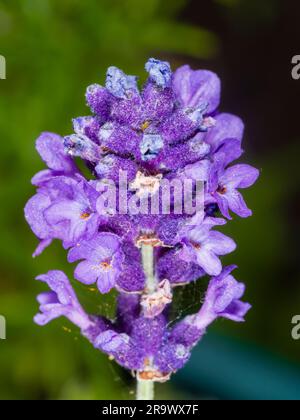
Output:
[180,218,236,276]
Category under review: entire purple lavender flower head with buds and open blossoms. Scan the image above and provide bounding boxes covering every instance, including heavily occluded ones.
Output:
[25,59,258,381]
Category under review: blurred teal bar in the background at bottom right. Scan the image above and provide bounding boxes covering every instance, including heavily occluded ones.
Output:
[174,333,300,400]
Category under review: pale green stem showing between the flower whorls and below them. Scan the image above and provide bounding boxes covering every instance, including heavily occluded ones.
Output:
[136,245,157,400]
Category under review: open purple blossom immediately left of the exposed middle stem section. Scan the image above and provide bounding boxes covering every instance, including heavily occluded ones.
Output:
[68,233,124,293]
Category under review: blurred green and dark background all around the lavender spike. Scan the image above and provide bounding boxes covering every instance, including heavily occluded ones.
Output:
[0,0,300,399]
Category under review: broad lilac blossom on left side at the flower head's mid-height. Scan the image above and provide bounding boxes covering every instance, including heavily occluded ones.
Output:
[25,176,99,255]
